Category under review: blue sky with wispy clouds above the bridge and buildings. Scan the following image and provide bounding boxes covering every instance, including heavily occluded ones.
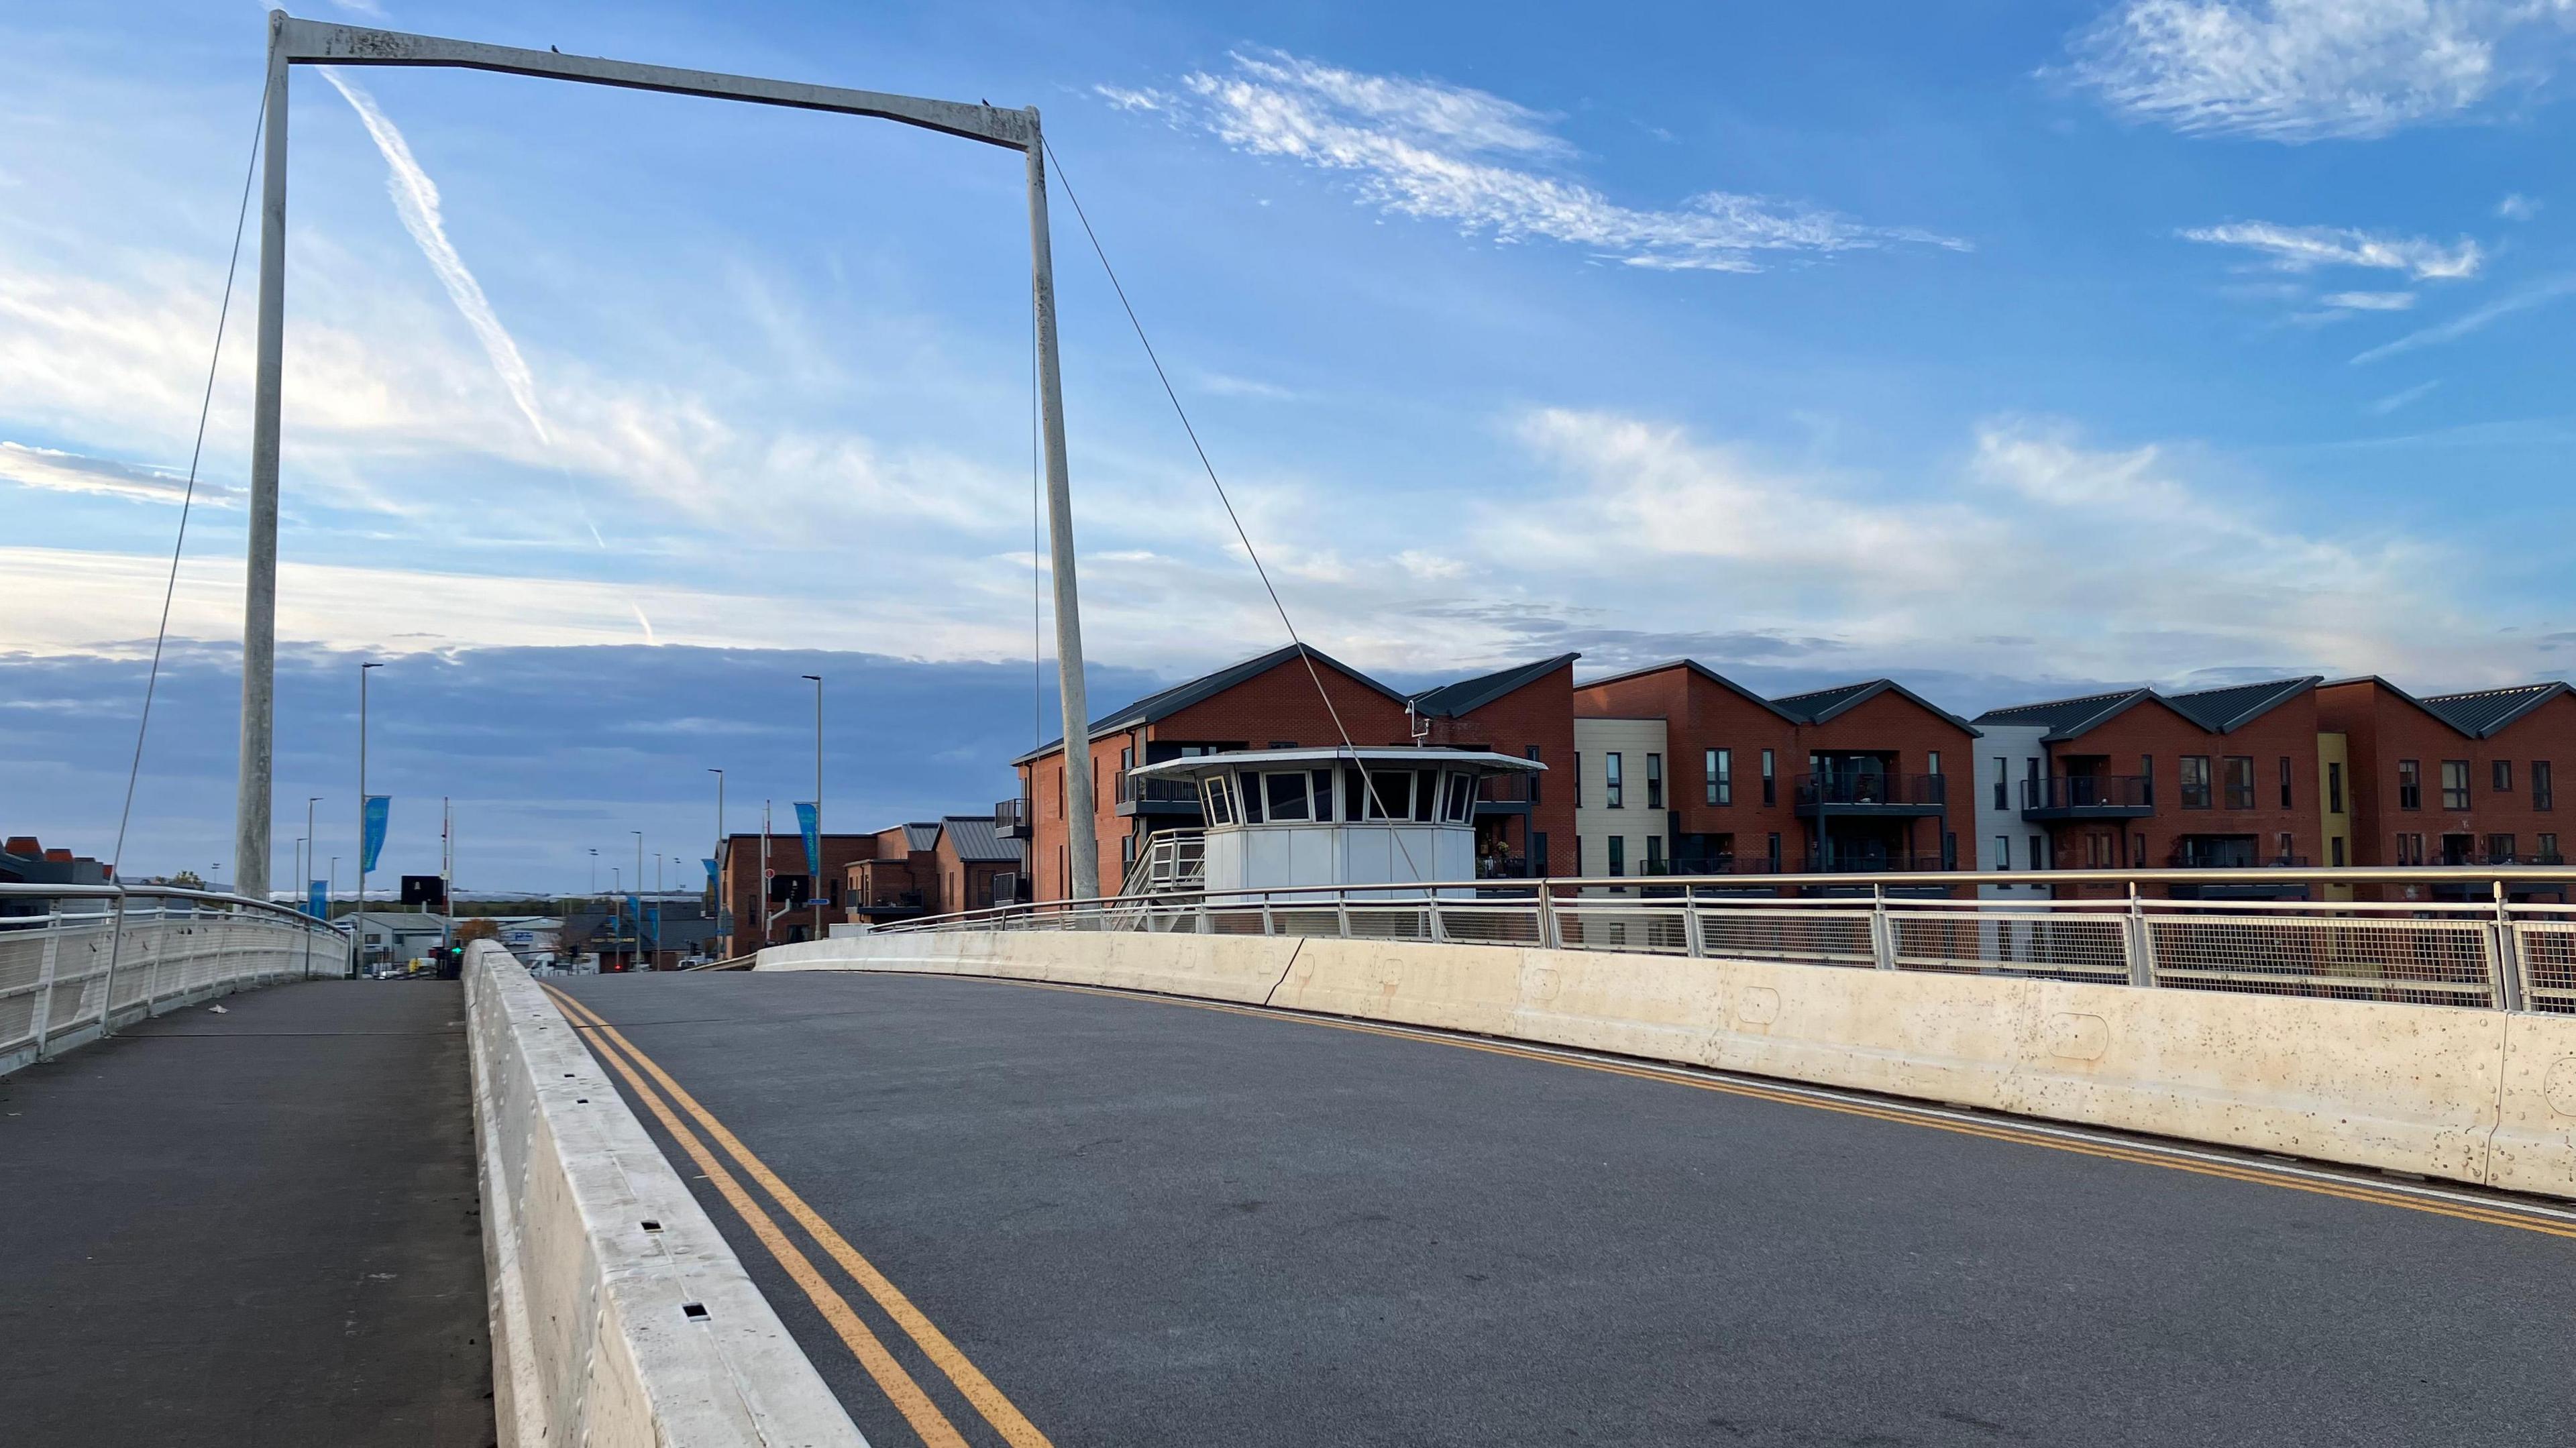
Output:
[0,0,2576,887]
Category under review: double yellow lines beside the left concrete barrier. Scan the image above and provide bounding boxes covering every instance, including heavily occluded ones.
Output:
[539,982,1054,1448]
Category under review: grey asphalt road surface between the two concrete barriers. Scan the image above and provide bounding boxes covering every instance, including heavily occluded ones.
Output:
[572,974,2576,1448]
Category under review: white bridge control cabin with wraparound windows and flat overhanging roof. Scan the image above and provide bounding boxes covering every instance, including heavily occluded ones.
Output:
[1136,744,1548,891]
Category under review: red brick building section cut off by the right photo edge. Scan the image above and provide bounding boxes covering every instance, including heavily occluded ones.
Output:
[2316,677,2576,886]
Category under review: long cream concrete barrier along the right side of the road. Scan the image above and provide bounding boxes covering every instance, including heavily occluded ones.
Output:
[757,930,2576,1196]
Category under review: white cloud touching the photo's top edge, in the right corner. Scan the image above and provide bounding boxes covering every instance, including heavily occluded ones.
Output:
[2069,0,2571,142]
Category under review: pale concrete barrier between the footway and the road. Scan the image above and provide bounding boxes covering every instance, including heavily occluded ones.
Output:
[466,940,865,1448]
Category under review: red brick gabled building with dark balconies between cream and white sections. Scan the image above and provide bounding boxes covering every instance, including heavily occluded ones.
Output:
[1574,659,1976,873]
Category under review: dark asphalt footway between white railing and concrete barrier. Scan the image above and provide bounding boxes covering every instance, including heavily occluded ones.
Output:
[0,982,492,1448]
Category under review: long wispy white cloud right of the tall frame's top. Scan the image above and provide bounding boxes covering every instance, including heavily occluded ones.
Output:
[1097,49,1968,270]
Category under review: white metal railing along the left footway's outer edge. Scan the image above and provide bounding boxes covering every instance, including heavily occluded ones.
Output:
[0,884,347,1074]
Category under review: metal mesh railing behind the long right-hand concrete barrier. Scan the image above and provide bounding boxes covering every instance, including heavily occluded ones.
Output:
[865,866,2576,1015]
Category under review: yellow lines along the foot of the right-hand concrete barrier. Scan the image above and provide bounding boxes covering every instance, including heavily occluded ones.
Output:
[979,971,2576,1237]
